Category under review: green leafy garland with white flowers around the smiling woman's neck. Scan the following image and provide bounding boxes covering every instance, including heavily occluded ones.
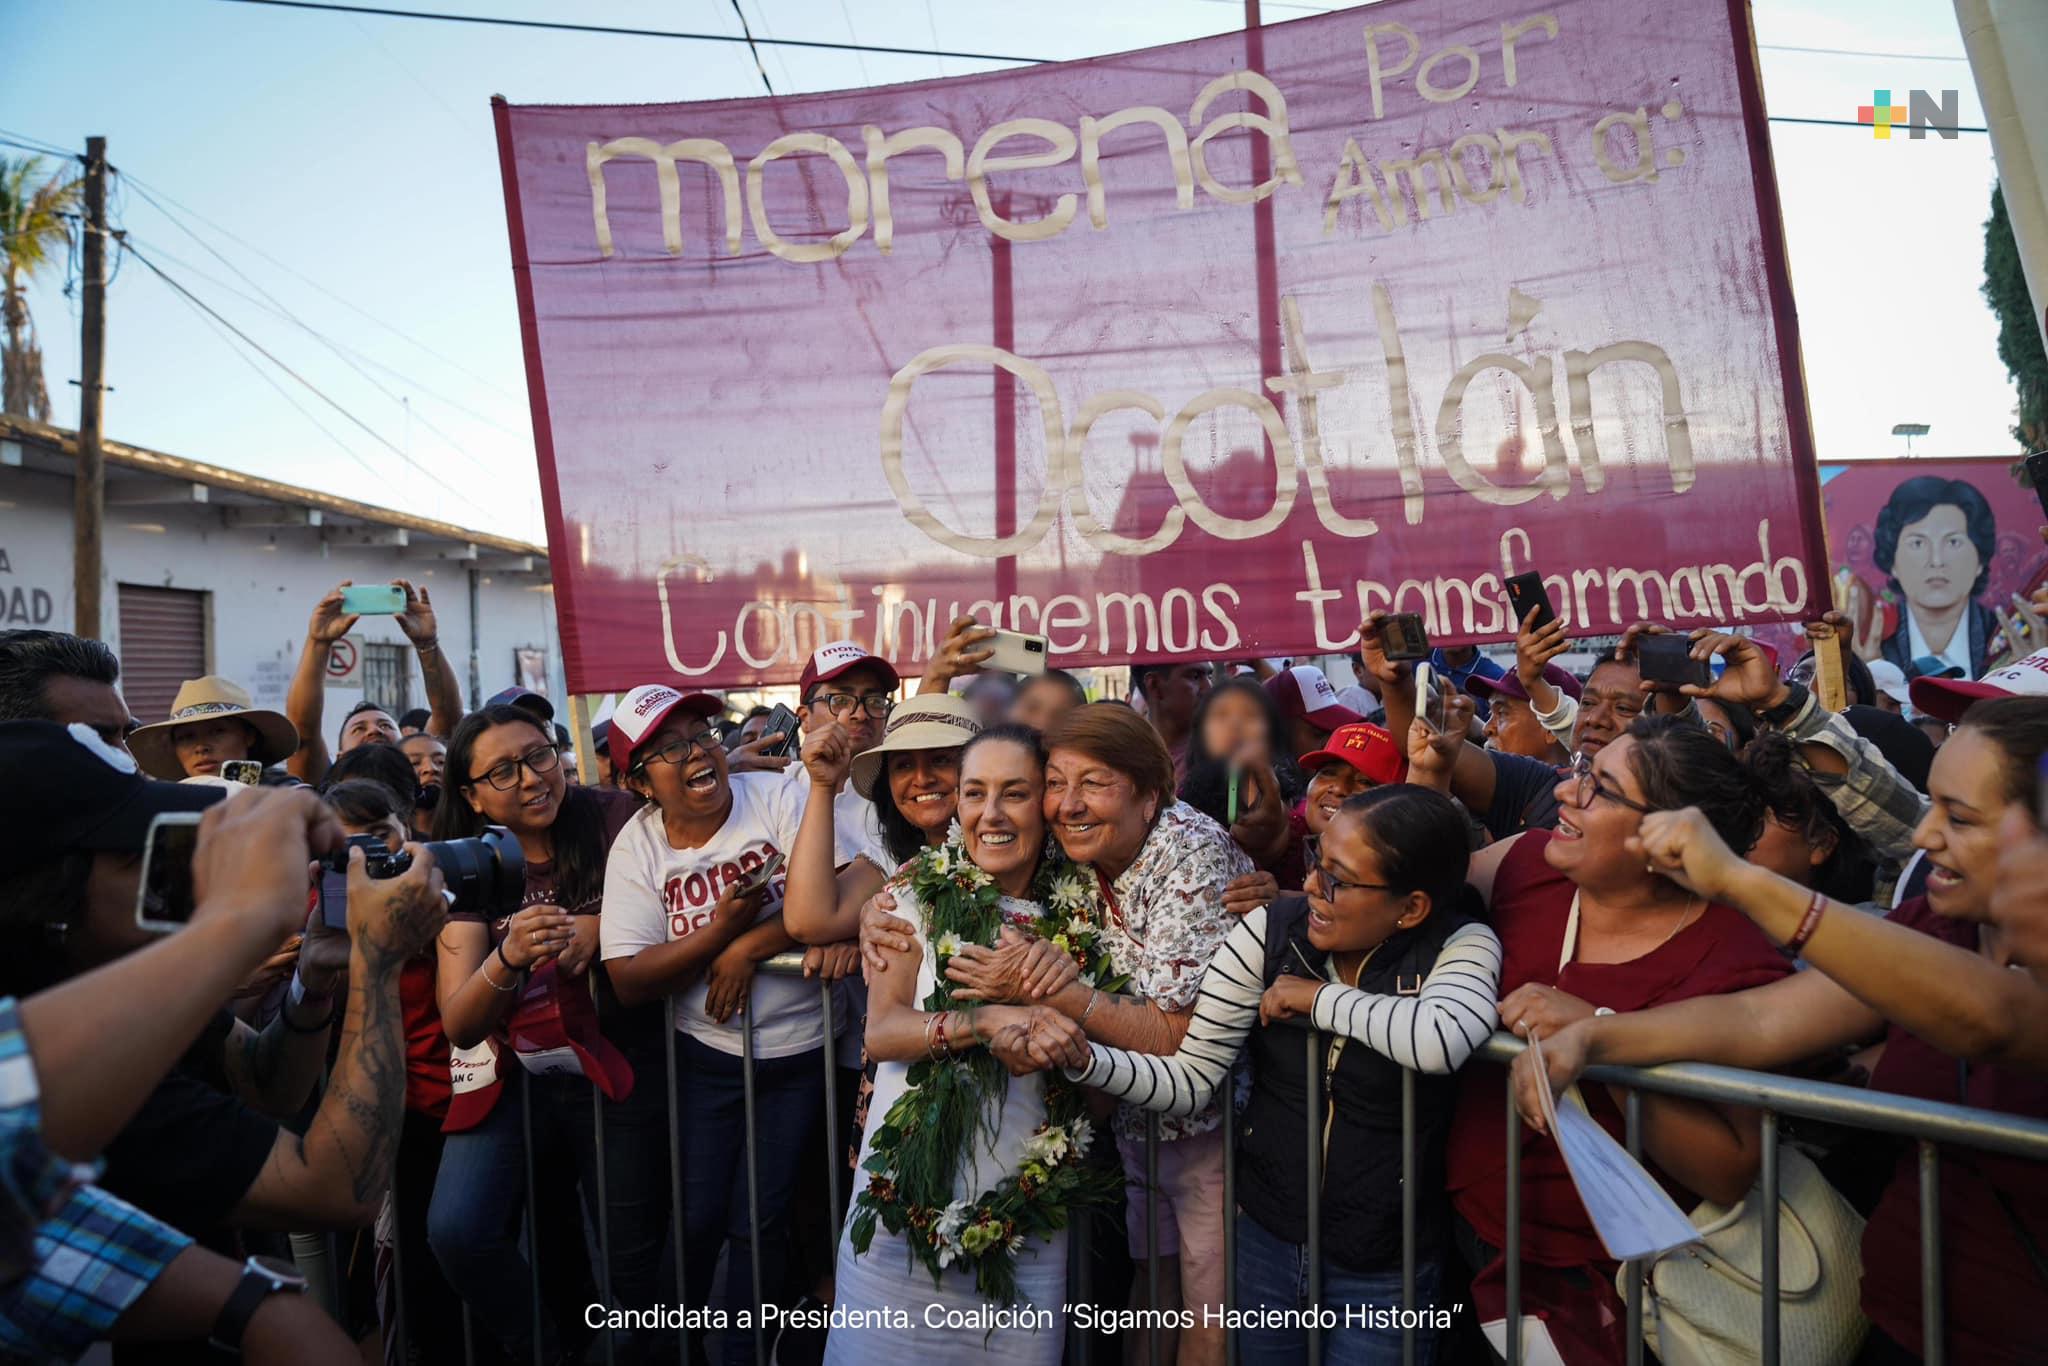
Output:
[850,823,1128,1307]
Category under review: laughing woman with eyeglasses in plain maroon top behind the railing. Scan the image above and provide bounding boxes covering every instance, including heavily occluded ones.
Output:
[1411,717,1788,1362]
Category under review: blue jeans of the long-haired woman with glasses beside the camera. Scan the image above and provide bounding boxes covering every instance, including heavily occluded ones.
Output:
[426,1055,668,1362]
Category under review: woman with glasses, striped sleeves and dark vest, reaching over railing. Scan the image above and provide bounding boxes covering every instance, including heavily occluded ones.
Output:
[1071,786,1501,1366]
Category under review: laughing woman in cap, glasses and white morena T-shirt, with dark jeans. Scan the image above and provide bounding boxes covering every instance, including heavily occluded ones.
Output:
[600,684,825,1366]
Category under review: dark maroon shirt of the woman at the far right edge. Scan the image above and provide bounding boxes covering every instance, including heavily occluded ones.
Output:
[1864,897,2048,1364]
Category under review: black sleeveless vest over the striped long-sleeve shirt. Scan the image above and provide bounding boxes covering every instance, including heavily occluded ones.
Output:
[1237,893,1481,1272]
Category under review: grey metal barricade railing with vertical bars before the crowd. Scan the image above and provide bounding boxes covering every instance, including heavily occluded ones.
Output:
[372,952,2048,1366]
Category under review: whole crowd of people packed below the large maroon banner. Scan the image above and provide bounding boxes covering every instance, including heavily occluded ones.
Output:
[0,569,2048,1366]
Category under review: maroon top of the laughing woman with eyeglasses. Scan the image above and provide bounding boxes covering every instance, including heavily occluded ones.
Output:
[1448,829,1790,1269]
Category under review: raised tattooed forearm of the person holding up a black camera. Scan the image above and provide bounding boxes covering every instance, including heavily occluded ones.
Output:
[233,844,446,1231]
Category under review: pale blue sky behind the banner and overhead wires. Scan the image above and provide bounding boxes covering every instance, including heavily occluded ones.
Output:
[0,0,2017,541]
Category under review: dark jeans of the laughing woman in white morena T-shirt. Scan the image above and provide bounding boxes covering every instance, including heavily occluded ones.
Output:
[676,1034,825,1366]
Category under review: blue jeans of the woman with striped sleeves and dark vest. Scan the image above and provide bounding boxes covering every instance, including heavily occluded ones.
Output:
[1237,1212,1440,1366]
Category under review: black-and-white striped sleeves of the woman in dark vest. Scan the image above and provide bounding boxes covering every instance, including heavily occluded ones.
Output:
[1067,907,1501,1114]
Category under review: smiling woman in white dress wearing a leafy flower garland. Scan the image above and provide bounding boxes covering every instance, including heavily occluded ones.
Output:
[825,725,1090,1366]
